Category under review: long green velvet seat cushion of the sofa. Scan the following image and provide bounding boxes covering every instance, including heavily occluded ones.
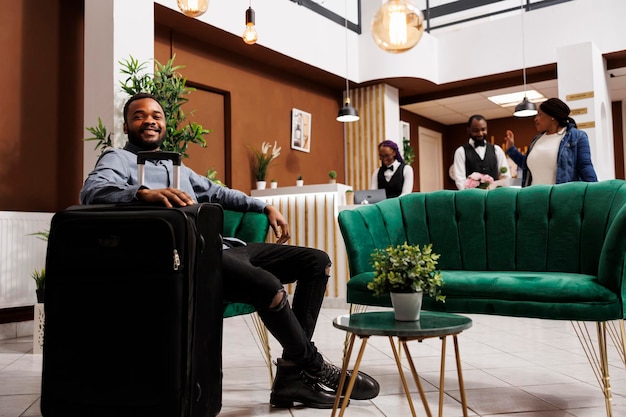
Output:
[348,271,621,320]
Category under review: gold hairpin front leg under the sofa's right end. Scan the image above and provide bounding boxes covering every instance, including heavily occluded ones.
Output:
[572,322,612,417]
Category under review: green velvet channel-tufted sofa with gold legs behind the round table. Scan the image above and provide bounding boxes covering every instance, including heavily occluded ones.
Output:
[338,180,626,415]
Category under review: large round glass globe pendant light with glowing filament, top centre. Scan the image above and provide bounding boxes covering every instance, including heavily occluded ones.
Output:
[372,0,424,53]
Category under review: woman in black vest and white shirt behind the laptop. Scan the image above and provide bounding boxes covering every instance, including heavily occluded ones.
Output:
[370,140,413,198]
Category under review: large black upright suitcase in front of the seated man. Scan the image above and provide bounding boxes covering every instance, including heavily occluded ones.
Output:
[41,204,223,417]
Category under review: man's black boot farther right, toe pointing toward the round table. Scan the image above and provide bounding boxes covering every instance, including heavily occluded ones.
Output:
[304,361,380,400]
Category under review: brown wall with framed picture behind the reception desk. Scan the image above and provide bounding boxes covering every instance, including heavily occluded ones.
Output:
[155,22,344,193]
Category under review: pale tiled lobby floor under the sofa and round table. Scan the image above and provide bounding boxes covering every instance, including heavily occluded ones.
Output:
[0,308,626,417]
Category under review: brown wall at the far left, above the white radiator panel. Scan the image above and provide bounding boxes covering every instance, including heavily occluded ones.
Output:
[0,0,84,211]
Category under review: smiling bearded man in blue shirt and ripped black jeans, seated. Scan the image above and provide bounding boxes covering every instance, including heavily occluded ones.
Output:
[80,93,379,408]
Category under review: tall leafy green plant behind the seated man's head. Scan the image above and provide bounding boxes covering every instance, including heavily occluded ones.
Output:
[85,56,212,157]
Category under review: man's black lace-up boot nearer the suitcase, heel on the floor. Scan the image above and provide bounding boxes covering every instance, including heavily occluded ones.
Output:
[270,359,349,408]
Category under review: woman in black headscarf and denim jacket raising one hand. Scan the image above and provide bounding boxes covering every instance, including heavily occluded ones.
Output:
[504,98,598,187]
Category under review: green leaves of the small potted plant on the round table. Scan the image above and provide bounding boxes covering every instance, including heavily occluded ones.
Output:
[367,242,445,302]
